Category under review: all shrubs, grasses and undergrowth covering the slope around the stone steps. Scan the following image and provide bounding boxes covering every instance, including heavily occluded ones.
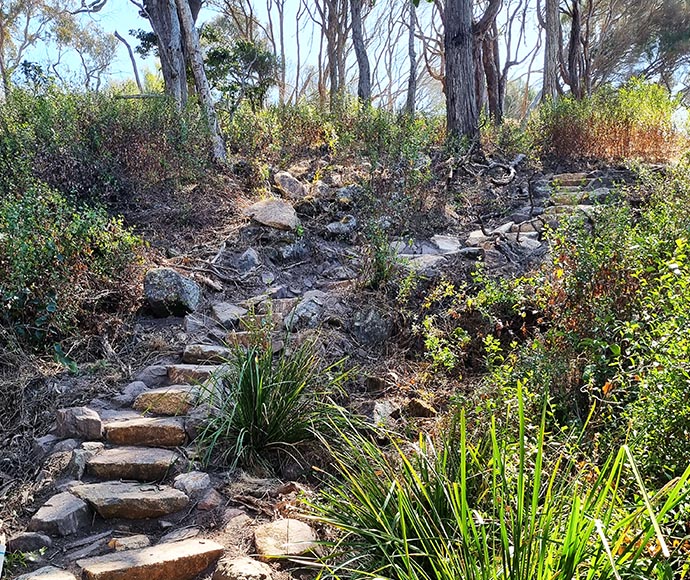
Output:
[0,80,690,580]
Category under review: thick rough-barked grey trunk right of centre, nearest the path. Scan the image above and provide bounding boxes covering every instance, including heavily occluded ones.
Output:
[444,0,479,141]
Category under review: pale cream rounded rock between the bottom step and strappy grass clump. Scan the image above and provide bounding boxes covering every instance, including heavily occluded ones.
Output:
[254,519,317,560]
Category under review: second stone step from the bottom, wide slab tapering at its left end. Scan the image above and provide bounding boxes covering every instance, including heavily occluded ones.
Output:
[72,481,189,520]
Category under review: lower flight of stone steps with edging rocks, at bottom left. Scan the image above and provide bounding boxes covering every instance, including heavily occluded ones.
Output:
[9,324,316,580]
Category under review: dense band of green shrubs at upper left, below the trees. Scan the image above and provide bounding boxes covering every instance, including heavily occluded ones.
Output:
[0,88,209,201]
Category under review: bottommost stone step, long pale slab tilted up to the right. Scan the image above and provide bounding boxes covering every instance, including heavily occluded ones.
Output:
[77,539,224,580]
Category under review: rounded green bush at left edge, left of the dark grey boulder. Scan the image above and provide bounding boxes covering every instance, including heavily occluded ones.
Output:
[0,185,141,344]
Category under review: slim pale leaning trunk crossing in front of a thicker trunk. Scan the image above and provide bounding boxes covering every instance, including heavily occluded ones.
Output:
[175,0,226,163]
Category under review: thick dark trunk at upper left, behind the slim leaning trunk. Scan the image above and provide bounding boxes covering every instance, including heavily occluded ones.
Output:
[144,0,189,107]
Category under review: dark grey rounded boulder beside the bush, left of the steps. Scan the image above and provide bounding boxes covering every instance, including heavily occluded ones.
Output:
[144,268,201,317]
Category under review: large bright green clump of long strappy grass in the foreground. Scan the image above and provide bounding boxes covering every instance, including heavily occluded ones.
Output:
[313,396,690,580]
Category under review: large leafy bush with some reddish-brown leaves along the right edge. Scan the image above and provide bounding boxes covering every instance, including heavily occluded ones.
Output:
[478,165,690,482]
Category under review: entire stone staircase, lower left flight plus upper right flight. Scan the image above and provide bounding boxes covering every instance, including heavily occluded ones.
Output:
[9,173,628,580]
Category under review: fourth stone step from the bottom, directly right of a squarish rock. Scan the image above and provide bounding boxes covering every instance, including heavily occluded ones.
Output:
[105,417,187,447]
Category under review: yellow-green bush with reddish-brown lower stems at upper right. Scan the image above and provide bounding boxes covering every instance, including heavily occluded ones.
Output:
[532,78,681,161]
